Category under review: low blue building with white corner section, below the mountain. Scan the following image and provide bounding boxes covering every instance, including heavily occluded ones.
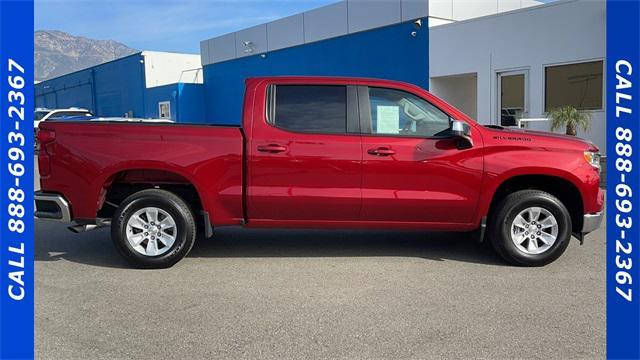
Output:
[35,51,205,122]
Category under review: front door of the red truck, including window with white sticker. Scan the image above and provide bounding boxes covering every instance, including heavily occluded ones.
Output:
[359,87,483,225]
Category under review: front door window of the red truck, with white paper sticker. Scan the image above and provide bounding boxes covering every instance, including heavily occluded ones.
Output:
[369,88,451,137]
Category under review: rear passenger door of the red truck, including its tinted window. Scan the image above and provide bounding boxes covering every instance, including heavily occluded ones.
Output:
[247,84,362,222]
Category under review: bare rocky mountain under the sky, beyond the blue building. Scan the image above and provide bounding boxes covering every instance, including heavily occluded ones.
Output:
[34,30,138,81]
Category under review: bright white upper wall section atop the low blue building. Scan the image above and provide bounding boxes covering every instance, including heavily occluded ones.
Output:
[142,51,202,88]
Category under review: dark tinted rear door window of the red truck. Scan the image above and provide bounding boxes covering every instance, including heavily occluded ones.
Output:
[273,85,347,133]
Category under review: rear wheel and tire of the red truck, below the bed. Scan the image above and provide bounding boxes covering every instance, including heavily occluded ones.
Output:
[111,189,197,269]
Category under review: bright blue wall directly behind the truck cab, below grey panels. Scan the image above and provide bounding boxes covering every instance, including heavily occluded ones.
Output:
[204,22,429,124]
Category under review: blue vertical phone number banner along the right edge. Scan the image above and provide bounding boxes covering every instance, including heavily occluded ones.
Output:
[607,0,640,359]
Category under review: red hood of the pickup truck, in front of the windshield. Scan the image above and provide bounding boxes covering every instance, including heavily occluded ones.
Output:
[484,125,599,152]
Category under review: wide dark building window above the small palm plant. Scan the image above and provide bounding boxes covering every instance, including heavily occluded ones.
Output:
[545,61,603,112]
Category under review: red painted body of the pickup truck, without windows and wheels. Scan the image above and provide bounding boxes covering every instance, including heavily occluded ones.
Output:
[39,77,603,231]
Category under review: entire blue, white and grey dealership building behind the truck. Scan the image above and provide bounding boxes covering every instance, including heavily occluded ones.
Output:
[36,0,606,152]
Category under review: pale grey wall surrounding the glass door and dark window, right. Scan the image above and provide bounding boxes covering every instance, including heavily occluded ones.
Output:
[429,0,606,153]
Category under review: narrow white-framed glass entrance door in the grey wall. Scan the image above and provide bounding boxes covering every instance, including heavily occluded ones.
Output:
[498,70,529,126]
